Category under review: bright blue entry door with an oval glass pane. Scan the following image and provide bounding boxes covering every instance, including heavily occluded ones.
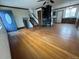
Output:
[0,10,17,32]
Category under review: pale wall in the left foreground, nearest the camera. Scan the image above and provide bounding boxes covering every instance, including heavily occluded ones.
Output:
[0,19,11,59]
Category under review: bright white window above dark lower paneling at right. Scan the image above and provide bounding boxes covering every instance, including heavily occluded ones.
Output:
[65,7,77,18]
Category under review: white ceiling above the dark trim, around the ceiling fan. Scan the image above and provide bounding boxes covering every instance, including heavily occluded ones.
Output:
[0,0,79,8]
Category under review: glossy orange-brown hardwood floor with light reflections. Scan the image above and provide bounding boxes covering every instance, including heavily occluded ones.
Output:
[9,24,79,59]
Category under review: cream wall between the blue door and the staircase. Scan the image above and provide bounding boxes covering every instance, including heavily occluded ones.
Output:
[0,7,28,28]
